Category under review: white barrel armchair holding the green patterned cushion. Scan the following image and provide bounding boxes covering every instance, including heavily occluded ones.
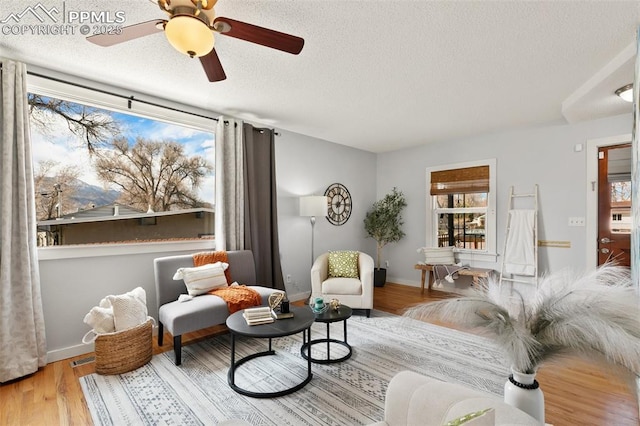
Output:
[311,252,374,317]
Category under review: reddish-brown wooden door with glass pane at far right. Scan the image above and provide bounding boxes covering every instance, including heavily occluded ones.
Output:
[598,144,631,267]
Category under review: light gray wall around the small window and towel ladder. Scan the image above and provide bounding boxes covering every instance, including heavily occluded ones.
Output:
[376,114,632,286]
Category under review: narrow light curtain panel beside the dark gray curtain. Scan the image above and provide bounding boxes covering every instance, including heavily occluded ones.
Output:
[215,117,245,250]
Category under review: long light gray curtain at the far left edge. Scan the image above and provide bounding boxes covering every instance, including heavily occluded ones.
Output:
[0,61,47,382]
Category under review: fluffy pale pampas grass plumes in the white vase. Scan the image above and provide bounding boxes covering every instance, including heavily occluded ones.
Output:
[405,265,640,377]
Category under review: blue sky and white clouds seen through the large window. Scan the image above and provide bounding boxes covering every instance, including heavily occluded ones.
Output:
[31,100,215,204]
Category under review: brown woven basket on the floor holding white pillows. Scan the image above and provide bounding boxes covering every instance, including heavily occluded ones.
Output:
[95,318,153,374]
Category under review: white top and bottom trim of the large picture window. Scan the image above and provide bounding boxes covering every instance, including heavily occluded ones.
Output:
[27,73,217,260]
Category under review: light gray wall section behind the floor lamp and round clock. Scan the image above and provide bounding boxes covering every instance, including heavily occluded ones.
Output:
[276,132,376,300]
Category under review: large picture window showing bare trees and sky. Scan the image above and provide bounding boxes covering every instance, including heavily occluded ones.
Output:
[29,79,215,247]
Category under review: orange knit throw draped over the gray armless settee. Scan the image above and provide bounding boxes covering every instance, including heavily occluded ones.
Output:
[193,251,262,314]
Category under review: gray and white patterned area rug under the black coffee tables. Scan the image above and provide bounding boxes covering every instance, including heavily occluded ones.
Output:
[80,311,509,426]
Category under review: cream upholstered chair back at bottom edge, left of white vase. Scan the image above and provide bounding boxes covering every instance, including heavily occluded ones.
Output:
[370,371,541,426]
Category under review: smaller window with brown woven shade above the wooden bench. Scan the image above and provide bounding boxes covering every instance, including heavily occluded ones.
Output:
[427,160,496,260]
